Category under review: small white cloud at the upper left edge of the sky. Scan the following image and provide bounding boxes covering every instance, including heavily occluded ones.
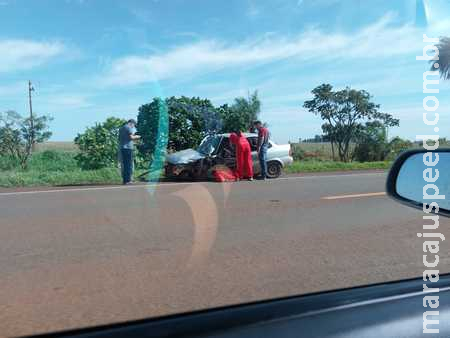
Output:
[0,40,65,73]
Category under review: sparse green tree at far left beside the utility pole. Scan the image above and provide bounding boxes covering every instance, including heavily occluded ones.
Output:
[0,111,52,169]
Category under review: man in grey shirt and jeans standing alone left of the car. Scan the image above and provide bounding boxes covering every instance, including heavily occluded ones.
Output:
[119,119,141,184]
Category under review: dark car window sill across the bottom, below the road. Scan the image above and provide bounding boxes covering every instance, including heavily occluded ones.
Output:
[29,275,450,338]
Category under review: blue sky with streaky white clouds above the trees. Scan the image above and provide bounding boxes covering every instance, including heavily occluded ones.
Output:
[0,0,450,142]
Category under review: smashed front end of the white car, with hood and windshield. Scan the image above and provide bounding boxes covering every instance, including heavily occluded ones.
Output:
[165,135,222,180]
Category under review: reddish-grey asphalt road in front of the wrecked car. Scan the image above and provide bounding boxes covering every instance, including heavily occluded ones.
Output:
[0,173,450,336]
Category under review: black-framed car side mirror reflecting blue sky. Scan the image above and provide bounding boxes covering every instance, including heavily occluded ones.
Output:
[386,149,450,217]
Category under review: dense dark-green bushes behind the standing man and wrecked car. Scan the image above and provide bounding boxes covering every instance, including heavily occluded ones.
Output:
[75,91,261,169]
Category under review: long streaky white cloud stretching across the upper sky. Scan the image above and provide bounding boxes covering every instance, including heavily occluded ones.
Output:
[102,14,440,85]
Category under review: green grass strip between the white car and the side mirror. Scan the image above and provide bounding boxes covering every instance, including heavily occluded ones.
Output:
[285,160,391,174]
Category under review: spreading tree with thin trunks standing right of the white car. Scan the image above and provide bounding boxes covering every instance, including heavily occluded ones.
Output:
[303,84,399,162]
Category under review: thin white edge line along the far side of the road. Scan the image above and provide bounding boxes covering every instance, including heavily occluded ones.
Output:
[0,173,385,197]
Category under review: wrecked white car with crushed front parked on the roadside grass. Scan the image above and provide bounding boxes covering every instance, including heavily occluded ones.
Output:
[165,133,293,180]
